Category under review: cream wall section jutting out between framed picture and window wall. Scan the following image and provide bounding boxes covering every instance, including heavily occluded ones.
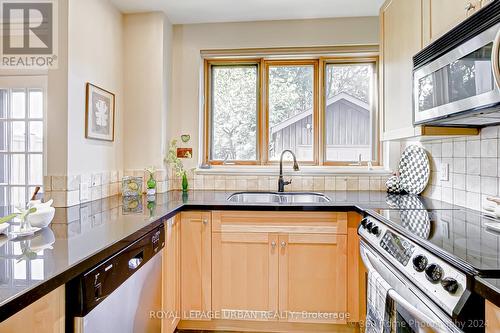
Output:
[123,12,172,170]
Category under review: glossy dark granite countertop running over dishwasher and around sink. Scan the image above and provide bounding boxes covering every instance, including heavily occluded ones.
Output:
[0,191,498,321]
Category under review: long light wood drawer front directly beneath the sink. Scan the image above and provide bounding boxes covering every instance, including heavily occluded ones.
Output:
[212,211,347,234]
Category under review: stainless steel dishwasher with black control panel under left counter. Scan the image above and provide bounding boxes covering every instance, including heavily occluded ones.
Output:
[66,225,165,333]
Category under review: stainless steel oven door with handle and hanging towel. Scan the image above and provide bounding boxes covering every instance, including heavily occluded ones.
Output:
[360,242,462,333]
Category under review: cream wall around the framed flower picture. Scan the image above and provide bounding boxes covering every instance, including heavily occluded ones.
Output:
[67,0,124,175]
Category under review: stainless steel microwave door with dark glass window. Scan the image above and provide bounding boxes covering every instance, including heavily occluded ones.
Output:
[413,24,500,125]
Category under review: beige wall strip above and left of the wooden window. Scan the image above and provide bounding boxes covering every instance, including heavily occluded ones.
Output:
[169,17,379,167]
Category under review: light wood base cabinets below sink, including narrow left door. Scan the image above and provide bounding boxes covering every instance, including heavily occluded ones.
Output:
[178,211,365,332]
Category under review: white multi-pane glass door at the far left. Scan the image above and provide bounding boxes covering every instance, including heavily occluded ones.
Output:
[0,83,45,206]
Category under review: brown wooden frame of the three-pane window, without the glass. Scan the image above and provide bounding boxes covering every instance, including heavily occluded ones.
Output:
[203,55,382,166]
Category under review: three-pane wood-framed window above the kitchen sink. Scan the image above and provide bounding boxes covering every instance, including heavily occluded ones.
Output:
[204,57,380,165]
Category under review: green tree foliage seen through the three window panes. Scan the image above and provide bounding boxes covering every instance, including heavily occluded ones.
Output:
[210,64,373,160]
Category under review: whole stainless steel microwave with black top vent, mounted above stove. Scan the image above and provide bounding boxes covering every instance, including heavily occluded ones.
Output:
[413,1,500,127]
